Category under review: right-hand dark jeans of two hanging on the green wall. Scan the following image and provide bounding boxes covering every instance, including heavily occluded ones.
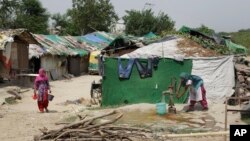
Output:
[135,58,153,78]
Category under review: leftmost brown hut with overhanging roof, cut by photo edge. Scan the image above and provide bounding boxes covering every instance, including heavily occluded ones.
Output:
[0,29,38,79]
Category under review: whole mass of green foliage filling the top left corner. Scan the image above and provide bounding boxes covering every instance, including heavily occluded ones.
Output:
[0,0,49,33]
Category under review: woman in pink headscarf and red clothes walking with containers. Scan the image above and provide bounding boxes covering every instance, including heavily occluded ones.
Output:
[34,68,51,113]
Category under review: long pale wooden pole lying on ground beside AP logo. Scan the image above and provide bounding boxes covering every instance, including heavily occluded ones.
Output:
[166,131,229,138]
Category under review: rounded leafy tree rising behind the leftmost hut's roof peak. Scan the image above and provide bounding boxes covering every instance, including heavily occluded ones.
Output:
[15,0,49,34]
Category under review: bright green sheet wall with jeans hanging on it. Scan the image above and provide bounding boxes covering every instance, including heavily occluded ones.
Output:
[102,58,192,106]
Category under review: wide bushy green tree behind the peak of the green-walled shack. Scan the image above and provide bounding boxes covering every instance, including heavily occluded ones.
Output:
[123,9,175,36]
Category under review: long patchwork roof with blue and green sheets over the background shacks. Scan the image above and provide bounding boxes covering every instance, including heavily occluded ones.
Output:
[30,32,115,56]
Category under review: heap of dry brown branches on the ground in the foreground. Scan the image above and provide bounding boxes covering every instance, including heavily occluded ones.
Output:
[34,111,152,141]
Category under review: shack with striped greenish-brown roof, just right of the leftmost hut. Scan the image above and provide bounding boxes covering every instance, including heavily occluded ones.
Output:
[34,34,88,80]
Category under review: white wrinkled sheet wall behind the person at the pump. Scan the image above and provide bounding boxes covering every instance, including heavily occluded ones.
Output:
[192,56,235,103]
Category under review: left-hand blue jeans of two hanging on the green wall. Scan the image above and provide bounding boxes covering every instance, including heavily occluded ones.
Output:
[118,58,135,79]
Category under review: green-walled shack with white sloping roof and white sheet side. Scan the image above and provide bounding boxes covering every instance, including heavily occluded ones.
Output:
[102,36,235,106]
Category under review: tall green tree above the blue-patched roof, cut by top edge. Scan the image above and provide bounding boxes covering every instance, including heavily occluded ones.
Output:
[68,0,118,34]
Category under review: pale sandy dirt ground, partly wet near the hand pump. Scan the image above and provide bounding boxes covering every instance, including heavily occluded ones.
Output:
[0,75,244,141]
